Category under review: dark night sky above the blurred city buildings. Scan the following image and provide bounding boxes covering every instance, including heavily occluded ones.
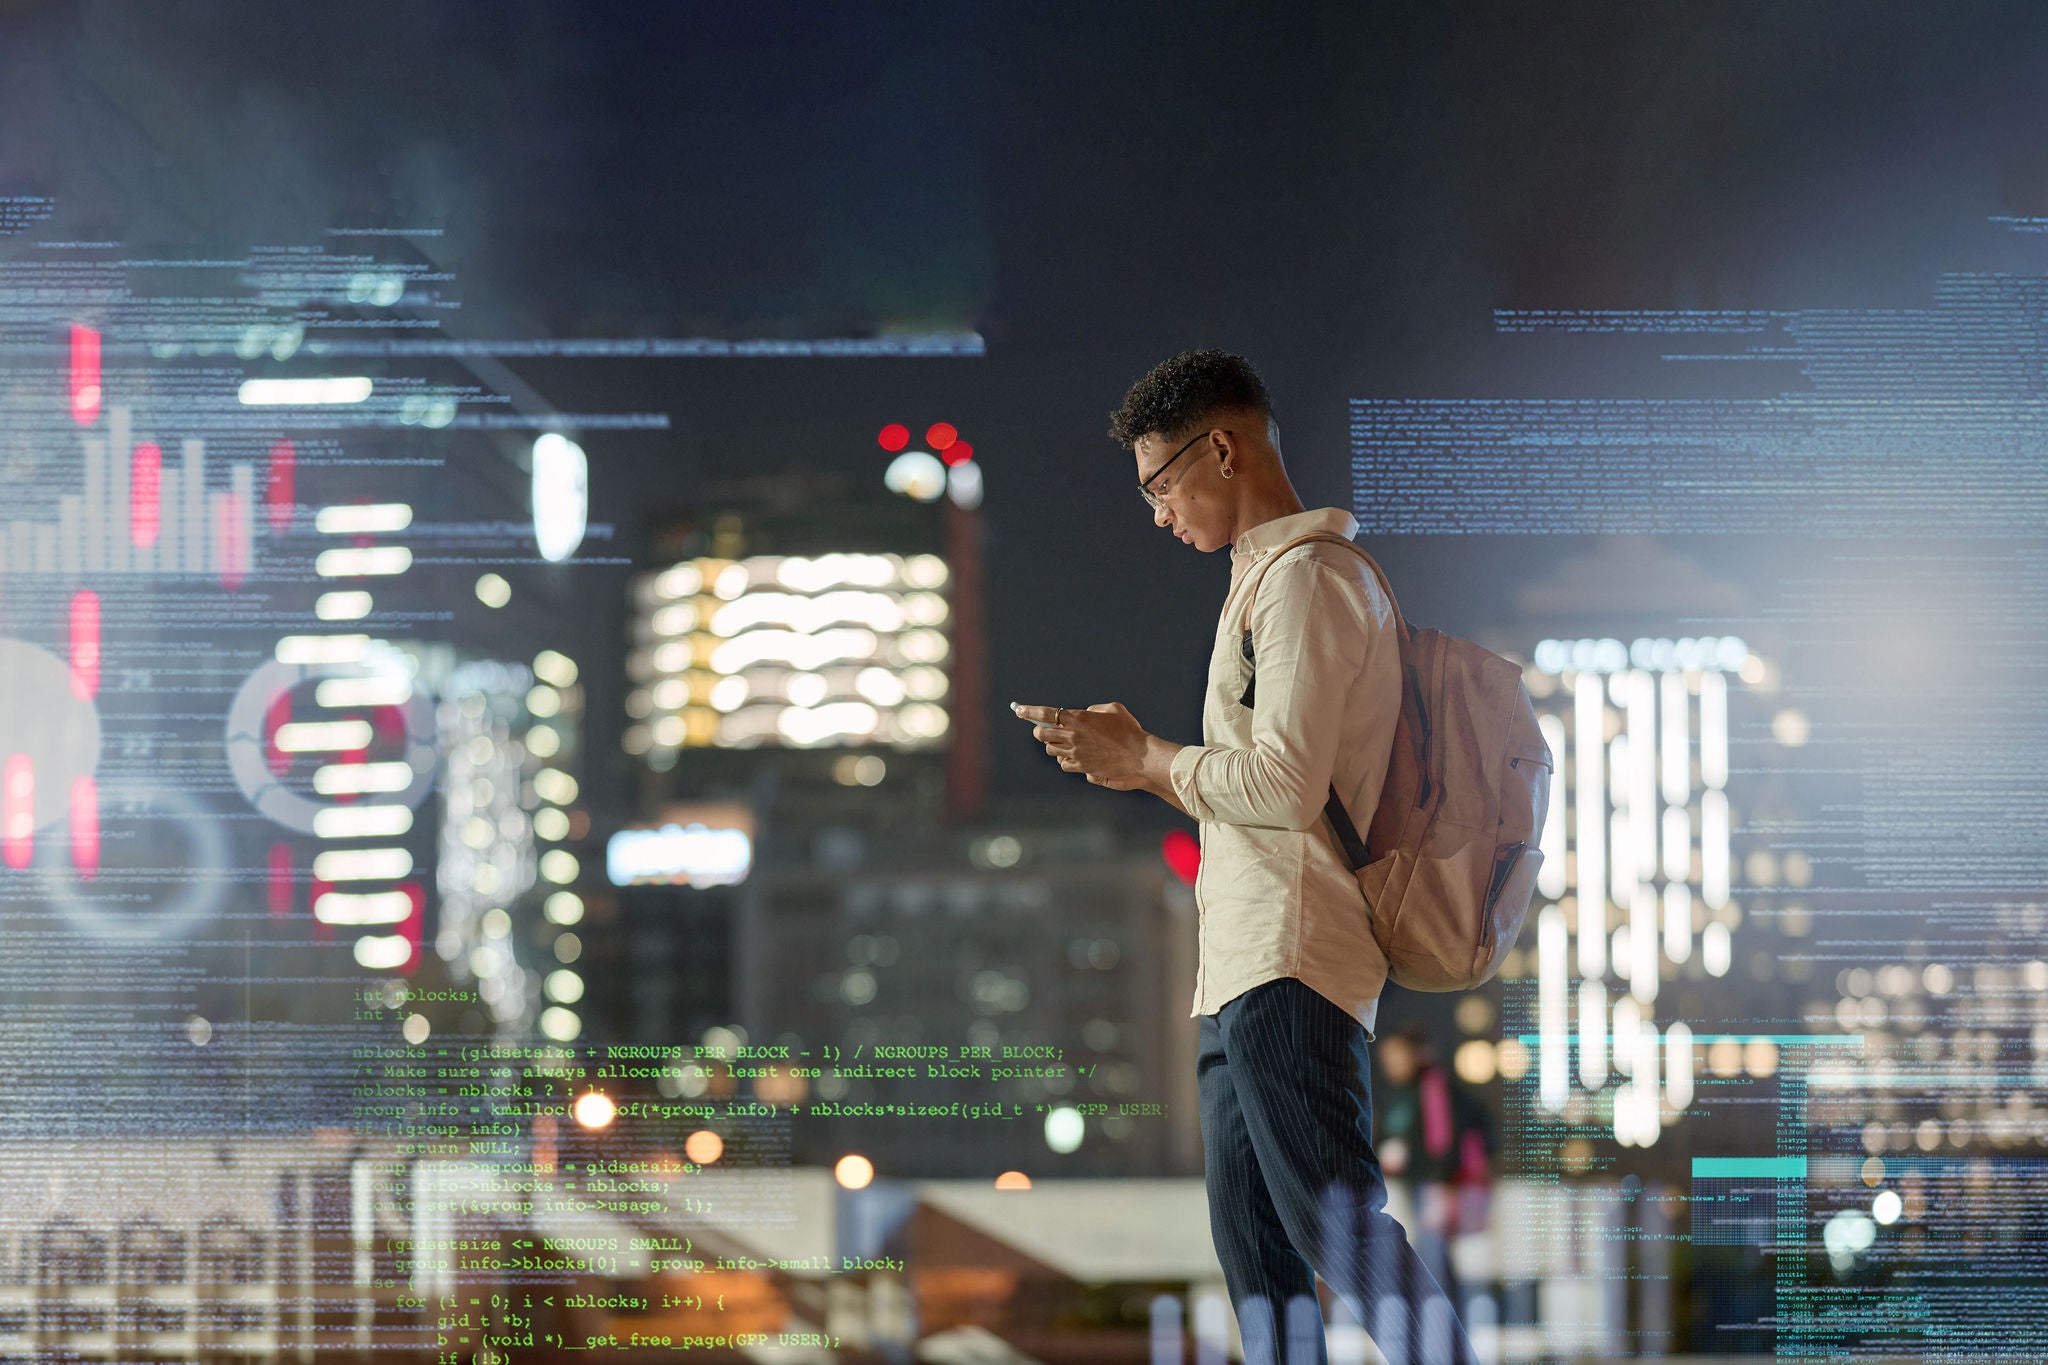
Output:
[0,0,2048,814]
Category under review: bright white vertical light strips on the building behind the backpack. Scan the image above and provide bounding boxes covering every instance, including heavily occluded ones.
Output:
[1526,636,1767,1146]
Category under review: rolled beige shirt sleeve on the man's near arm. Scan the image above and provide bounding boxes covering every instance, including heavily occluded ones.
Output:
[1169,555,1401,829]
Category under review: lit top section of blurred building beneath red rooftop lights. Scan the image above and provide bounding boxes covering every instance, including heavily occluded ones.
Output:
[623,475,983,819]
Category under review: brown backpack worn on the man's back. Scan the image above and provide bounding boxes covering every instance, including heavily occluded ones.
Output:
[1243,532,1556,990]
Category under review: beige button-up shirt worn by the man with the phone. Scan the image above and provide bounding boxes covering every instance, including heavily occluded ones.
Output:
[1171,508,1401,1036]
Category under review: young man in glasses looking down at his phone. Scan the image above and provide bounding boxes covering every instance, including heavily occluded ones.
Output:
[1012,350,1477,1365]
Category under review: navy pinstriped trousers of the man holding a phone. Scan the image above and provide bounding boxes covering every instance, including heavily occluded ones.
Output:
[1196,976,1479,1365]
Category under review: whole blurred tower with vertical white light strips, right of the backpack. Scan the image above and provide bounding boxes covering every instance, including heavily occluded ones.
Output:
[1490,544,1810,1173]
